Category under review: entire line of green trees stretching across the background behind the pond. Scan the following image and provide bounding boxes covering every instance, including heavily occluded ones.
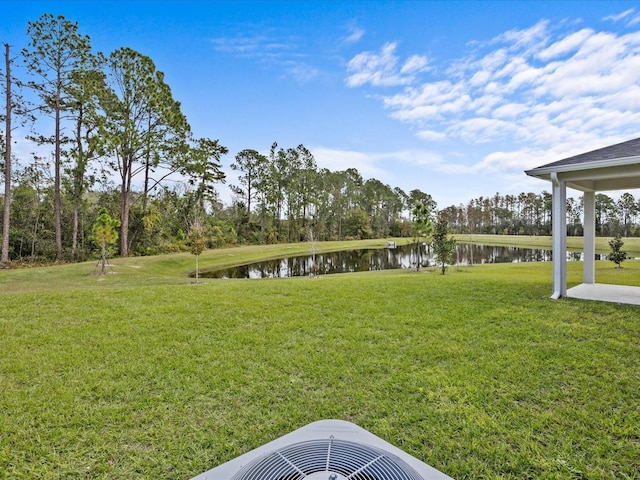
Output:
[0,14,640,264]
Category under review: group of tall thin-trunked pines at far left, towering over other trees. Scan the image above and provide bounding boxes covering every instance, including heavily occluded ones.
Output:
[0,14,227,262]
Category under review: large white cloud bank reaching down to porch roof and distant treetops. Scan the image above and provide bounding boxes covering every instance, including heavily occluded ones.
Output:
[342,12,640,206]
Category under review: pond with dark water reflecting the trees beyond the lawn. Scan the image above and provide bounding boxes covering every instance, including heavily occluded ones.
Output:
[200,243,581,278]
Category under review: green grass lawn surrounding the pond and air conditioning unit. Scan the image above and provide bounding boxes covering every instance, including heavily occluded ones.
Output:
[0,245,640,479]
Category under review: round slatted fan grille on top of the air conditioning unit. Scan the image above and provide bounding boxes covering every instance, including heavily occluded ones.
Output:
[231,438,424,480]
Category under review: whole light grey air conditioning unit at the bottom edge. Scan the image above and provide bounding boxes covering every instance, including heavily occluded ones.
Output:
[192,420,452,480]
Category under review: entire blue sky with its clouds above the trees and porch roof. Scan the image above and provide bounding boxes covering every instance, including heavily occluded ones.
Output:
[0,0,640,208]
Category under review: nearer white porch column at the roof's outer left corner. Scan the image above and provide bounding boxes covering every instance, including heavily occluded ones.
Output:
[551,172,567,300]
